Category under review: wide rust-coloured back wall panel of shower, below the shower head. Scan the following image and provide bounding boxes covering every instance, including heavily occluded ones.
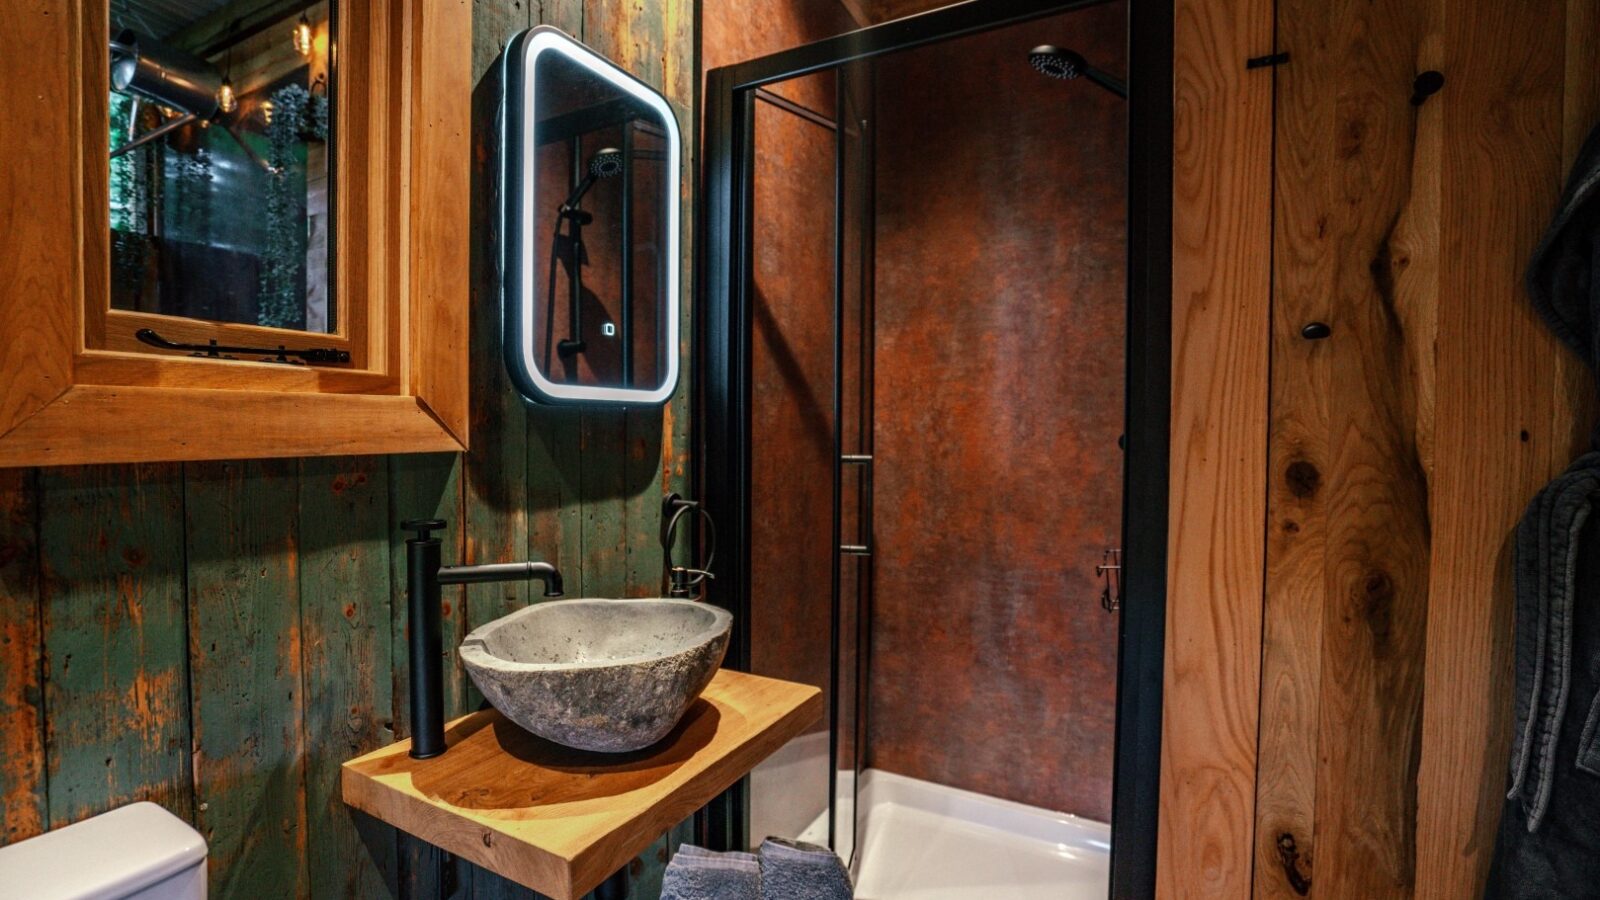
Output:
[869,3,1126,820]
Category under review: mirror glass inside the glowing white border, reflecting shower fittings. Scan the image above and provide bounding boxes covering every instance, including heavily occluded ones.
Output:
[531,45,677,391]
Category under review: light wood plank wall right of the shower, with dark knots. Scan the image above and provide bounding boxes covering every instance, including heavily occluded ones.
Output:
[1158,0,1600,898]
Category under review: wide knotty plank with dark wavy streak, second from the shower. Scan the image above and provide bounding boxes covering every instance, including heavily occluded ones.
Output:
[1256,0,1437,897]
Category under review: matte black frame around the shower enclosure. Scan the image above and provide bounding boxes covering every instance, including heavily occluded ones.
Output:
[694,0,1173,898]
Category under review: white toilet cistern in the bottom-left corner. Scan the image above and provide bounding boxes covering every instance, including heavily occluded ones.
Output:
[0,802,205,900]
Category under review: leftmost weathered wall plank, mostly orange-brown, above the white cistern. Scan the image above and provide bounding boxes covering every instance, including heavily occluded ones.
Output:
[0,469,46,846]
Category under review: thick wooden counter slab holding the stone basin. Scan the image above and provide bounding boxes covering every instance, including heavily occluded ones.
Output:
[342,669,822,900]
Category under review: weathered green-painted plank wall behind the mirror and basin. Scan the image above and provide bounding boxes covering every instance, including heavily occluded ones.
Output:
[0,0,698,900]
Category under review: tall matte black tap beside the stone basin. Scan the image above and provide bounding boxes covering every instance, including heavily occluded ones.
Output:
[400,519,562,759]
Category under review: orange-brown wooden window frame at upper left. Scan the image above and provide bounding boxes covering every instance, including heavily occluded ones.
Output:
[0,0,472,466]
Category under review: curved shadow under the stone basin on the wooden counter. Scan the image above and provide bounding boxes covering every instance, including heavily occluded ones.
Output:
[403,698,722,810]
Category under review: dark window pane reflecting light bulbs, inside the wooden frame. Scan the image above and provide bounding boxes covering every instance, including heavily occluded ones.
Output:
[109,0,338,333]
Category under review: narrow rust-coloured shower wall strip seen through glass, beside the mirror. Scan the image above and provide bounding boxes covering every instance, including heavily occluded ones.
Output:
[750,91,834,707]
